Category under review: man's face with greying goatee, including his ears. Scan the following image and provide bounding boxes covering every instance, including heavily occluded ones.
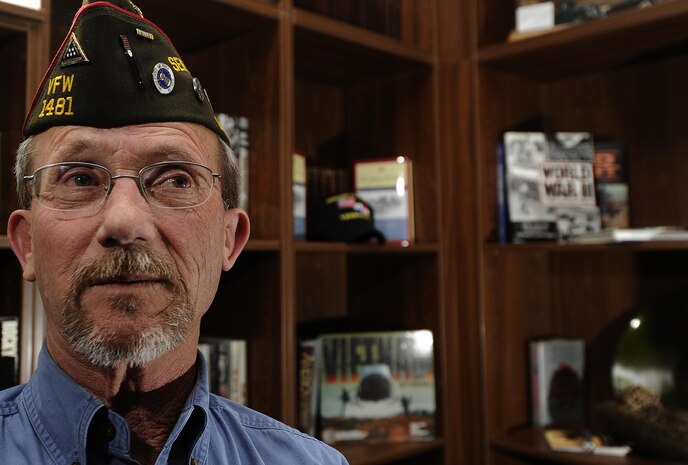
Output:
[9,123,248,366]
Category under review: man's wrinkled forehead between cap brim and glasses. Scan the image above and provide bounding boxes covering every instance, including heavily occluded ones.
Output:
[31,123,219,170]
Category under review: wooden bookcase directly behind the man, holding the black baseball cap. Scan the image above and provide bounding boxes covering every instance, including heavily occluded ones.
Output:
[0,0,476,465]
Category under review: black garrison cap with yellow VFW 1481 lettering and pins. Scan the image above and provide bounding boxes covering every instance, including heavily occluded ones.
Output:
[24,0,229,142]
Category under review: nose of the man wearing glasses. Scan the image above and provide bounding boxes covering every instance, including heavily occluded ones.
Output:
[96,176,155,246]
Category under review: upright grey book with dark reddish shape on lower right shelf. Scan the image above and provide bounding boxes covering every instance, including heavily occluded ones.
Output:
[529,338,585,427]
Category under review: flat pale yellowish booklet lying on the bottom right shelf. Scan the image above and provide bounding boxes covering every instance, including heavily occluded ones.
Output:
[543,429,631,457]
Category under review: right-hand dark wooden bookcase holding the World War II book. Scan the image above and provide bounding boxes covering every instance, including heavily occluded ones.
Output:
[464,0,688,464]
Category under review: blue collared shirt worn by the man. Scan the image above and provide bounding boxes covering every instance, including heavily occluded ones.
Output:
[0,347,347,465]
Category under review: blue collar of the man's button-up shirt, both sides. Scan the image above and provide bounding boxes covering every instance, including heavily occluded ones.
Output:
[24,345,210,464]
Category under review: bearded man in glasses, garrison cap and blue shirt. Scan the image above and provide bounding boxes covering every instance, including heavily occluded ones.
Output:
[0,0,346,465]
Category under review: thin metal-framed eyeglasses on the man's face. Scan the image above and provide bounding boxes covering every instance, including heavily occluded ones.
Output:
[24,161,222,214]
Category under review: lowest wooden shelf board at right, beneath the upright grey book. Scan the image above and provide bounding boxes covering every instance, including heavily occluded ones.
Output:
[491,427,668,465]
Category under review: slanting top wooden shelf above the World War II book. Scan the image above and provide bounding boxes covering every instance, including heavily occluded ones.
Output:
[477,0,688,80]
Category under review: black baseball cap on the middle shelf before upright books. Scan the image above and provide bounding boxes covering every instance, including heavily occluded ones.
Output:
[306,192,385,244]
